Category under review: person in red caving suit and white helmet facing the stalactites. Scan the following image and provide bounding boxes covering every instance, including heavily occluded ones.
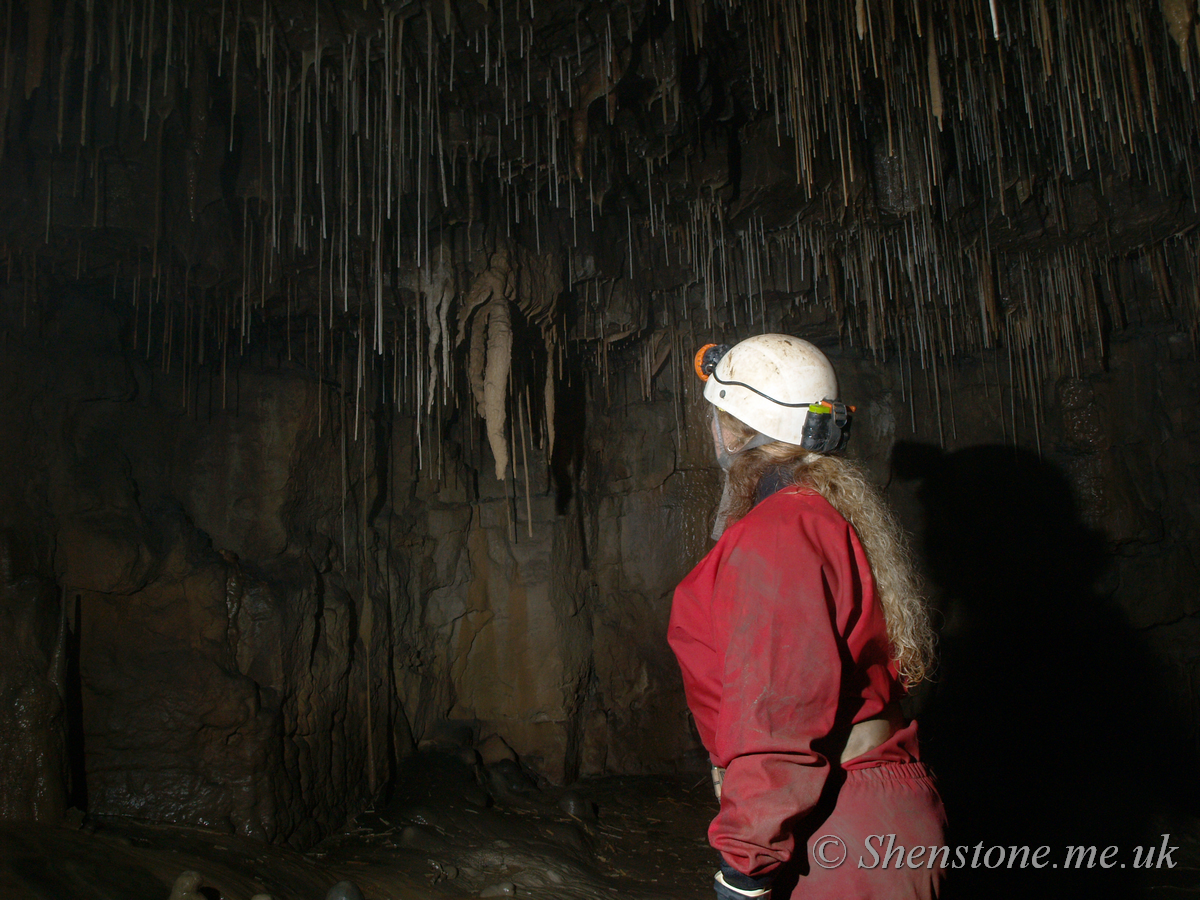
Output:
[667,335,946,900]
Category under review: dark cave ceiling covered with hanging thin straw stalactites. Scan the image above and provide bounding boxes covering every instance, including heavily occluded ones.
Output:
[0,0,1200,448]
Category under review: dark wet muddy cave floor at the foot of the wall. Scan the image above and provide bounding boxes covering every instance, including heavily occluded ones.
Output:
[7,752,1200,900]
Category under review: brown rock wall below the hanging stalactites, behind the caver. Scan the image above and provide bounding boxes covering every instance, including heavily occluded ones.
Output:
[0,282,1200,845]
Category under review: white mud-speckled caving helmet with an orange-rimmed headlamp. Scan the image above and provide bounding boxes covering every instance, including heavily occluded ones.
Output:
[696,335,853,452]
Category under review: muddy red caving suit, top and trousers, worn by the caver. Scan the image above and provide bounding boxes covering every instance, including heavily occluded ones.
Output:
[668,487,944,900]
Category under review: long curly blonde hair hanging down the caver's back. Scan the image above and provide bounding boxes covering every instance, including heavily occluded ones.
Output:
[716,410,935,689]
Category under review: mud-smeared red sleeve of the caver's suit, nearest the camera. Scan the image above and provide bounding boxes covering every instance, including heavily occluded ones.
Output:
[668,492,874,875]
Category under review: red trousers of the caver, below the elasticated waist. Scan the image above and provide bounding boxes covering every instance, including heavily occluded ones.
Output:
[775,762,946,900]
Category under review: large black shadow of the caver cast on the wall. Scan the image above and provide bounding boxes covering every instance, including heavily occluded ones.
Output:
[893,443,1196,898]
